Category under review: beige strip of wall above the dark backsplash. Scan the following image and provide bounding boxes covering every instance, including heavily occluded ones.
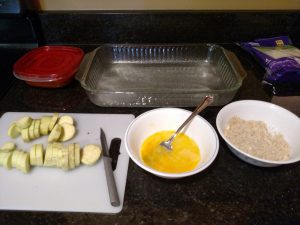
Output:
[35,0,300,10]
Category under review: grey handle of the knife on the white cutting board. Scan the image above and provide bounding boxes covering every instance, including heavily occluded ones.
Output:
[103,156,120,206]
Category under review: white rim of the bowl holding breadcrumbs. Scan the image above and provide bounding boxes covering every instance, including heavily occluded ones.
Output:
[216,100,300,165]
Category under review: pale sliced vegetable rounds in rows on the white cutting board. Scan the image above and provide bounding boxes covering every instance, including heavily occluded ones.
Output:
[0,113,102,173]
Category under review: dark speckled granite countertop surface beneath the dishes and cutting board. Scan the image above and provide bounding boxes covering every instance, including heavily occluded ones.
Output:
[0,46,300,225]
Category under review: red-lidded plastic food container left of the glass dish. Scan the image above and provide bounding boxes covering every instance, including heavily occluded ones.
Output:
[13,46,84,88]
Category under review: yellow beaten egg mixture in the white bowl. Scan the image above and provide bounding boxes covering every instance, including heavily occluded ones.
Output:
[140,130,200,173]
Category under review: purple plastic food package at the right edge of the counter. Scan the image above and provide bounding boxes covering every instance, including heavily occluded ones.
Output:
[238,36,300,95]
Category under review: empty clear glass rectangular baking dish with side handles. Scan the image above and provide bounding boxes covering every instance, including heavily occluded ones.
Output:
[76,44,246,107]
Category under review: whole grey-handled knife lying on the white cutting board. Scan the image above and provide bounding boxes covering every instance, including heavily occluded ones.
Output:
[100,128,120,207]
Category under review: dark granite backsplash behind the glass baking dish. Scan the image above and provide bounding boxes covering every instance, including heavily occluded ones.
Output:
[38,11,300,45]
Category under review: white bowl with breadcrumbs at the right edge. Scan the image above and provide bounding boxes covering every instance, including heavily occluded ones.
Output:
[216,100,300,167]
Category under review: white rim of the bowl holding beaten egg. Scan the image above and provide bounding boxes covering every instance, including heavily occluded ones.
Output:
[125,108,219,178]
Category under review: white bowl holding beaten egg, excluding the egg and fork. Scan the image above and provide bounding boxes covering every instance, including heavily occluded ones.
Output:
[125,108,219,179]
